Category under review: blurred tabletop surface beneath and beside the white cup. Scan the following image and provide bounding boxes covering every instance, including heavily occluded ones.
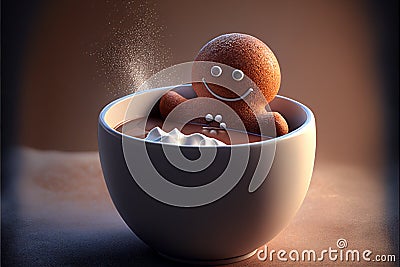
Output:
[2,148,398,266]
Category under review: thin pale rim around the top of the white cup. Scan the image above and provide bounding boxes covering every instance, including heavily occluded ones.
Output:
[99,85,314,148]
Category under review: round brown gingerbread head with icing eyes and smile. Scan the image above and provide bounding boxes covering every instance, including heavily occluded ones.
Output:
[193,33,281,110]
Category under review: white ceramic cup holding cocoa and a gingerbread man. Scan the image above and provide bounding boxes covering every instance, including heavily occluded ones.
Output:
[98,86,316,264]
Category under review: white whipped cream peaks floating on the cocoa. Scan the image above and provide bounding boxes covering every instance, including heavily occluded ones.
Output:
[145,127,226,146]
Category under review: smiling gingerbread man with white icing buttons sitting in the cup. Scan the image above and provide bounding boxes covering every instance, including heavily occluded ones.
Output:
[160,33,289,136]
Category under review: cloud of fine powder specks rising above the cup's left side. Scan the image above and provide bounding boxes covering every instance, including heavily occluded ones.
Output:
[91,1,170,97]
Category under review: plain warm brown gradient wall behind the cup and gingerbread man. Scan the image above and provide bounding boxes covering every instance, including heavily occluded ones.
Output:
[19,0,383,170]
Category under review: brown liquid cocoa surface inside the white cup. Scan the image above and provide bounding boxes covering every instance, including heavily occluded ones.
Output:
[115,117,270,145]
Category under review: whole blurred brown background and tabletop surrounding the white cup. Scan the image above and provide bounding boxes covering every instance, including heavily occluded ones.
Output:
[1,0,399,266]
